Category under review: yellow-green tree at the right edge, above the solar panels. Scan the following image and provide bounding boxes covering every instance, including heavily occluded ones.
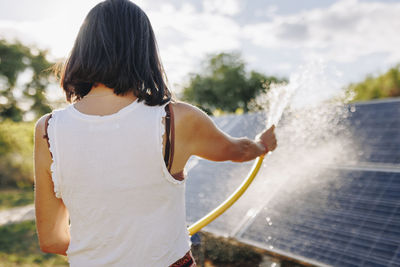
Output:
[347,64,400,101]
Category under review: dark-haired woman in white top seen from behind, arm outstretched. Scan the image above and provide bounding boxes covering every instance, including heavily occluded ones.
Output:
[34,0,276,266]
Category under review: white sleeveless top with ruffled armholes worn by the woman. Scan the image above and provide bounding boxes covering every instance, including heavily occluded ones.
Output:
[48,100,191,267]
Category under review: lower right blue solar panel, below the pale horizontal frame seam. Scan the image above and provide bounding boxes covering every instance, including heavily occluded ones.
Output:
[239,171,400,266]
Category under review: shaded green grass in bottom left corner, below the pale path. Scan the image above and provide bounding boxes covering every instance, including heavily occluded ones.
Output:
[0,221,68,267]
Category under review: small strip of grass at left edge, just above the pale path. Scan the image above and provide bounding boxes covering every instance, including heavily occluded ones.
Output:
[0,189,34,210]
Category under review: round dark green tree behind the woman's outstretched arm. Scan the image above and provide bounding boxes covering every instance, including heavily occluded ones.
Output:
[183,53,283,112]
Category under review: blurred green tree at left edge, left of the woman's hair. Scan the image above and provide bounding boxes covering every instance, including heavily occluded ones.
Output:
[0,39,53,121]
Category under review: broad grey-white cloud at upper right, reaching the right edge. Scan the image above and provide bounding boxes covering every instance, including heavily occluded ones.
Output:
[243,0,400,62]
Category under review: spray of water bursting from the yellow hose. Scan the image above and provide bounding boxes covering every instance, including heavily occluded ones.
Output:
[222,62,360,243]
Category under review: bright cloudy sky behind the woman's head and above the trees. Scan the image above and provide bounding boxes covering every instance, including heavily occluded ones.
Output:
[0,0,400,96]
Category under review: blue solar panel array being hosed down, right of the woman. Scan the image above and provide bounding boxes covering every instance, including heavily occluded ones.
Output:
[186,101,400,266]
